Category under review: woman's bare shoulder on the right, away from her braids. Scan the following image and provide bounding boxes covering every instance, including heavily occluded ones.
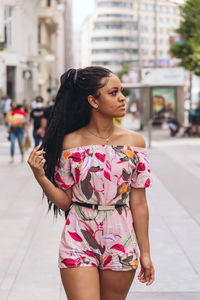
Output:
[118,128,146,148]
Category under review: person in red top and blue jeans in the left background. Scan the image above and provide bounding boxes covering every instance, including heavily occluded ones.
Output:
[6,101,27,164]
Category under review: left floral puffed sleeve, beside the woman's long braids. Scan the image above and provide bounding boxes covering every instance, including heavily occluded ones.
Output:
[54,151,74,191]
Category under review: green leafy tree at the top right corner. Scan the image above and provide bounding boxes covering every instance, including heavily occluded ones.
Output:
[170,0,200,76]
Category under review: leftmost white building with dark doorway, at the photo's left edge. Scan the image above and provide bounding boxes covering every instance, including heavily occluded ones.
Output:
[0,0,39,102]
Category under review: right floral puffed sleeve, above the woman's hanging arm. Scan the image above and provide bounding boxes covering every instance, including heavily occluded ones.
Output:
[131,148,152,188]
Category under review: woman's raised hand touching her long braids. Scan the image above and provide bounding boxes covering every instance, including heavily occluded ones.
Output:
[28,145,46,179]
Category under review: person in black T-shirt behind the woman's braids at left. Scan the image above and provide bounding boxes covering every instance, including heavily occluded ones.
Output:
[29,96,45,147]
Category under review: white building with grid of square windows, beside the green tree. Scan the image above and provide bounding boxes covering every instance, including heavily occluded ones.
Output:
[138,0,181,67]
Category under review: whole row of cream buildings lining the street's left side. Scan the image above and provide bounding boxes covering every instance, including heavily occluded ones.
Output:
[0,0,72,103]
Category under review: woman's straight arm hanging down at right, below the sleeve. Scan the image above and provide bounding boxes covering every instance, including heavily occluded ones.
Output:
[130,188,154,285]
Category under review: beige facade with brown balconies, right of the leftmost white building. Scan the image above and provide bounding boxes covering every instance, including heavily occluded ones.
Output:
[37,0,64,101]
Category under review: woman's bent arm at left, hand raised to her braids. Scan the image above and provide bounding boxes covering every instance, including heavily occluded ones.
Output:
[28,146,72,211]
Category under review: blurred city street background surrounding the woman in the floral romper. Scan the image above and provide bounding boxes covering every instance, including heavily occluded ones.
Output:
[0,0,200,300]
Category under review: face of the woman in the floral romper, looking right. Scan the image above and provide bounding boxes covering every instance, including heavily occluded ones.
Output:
[95,74,126,118]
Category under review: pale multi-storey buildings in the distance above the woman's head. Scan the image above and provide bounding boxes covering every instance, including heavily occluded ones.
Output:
[81,0,180,72]
